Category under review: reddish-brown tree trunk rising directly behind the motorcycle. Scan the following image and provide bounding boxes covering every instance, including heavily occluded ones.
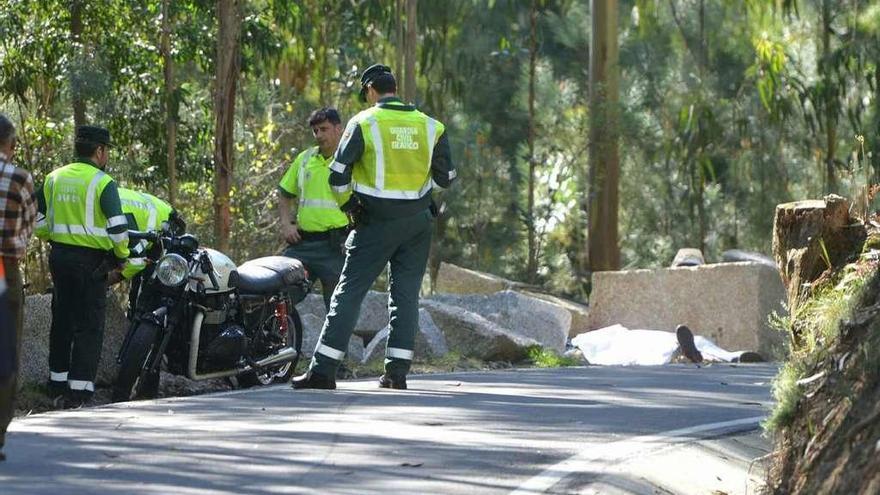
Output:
[214,0,241,251]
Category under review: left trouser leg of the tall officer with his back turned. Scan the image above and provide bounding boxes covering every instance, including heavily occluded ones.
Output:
[310,223,393,378]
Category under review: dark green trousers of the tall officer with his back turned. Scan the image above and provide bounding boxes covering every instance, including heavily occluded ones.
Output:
[311,210,433,378]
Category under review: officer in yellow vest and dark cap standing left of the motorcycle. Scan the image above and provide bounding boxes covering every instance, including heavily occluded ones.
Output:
[36,126,128,405]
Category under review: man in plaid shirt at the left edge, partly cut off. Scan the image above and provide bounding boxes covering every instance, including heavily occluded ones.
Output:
[0,114,37,461]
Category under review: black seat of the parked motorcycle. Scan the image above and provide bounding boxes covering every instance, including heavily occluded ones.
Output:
[229,256,306,294]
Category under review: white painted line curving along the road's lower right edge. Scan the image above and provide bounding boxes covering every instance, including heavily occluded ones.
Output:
[511,416,765,495]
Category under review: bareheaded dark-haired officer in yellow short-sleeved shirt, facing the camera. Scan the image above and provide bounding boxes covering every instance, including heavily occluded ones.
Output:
[278,108,348,309]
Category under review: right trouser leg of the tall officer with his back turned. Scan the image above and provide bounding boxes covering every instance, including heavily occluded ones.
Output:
[385,211,431,375]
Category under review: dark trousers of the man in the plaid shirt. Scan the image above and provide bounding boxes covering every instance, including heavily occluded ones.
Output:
[0,258,24,449]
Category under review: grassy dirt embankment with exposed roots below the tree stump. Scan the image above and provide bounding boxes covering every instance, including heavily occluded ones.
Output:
[767,196,880,494]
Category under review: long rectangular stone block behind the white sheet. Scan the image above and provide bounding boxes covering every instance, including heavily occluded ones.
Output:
[590,262,785,358]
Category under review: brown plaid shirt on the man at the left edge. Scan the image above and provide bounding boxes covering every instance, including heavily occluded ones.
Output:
[0,153,37,259]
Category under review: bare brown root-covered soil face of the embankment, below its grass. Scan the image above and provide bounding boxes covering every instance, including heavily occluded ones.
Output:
[768,273,880,494]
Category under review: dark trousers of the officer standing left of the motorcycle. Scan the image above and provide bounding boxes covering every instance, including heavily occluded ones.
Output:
[49,245,107,391]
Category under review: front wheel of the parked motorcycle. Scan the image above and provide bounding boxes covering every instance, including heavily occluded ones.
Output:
[113,321,159,402]
